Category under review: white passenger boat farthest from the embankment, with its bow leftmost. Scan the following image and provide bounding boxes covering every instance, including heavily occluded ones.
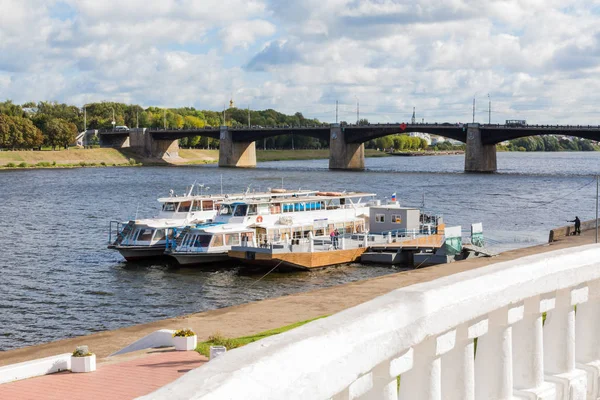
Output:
[108,185,315,261]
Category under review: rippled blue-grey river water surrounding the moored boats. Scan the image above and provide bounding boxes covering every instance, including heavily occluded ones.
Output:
[0,152,600,351]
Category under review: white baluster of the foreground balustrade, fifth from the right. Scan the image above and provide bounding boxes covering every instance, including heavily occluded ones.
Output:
[442,324,475,400]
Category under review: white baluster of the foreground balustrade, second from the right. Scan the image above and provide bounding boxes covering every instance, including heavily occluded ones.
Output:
[544,289,587,400]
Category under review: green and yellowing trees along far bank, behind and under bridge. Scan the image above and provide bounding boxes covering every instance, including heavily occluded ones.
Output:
[0,100,599,151]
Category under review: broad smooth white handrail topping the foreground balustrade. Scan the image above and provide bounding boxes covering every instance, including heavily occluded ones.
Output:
[143,245,600,400]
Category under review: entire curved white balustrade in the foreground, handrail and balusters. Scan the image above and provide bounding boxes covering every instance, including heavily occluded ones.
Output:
[143,245,600,400]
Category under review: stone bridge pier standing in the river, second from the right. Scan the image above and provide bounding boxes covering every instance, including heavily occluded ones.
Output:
[329,124,365,170]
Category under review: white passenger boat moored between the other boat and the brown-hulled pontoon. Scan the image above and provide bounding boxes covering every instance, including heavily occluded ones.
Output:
[166,192,376,265]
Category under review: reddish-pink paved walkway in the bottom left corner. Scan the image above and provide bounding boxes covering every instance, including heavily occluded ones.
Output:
[0,351,206,400]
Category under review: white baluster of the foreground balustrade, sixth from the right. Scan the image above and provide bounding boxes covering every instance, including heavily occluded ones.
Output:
[399,338,442,400]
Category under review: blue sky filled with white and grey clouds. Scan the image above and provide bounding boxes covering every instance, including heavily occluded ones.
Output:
[0,0,600,125]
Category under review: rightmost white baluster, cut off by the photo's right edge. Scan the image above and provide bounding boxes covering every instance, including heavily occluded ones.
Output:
[575,280,600,399]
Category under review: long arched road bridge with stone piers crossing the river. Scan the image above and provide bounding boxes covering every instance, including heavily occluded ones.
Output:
[99,123,600,172]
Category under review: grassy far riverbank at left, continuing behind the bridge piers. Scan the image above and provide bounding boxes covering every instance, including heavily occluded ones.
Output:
[0,148,389,170]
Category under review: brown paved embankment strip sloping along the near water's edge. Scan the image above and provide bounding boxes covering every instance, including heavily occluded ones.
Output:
[0,225,595,366]
